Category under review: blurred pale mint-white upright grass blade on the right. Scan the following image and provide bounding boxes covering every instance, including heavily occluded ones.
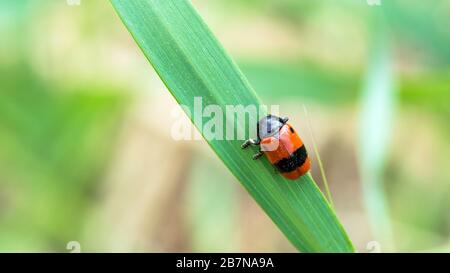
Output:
[359,13,396,251]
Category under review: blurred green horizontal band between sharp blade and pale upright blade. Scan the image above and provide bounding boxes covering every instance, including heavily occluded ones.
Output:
[239,61,358,104]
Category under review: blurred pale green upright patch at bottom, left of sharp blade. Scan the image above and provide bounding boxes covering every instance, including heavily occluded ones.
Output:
[185,157,240,252]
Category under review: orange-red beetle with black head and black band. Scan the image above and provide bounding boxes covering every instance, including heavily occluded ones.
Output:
[241,115,311,180]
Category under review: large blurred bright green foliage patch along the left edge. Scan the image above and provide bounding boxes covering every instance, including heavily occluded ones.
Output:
[0,65,126,251]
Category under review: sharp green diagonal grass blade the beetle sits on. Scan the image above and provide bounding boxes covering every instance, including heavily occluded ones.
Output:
[111,0,354,252]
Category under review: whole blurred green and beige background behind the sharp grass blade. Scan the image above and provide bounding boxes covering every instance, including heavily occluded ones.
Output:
[0,0,450,252]
